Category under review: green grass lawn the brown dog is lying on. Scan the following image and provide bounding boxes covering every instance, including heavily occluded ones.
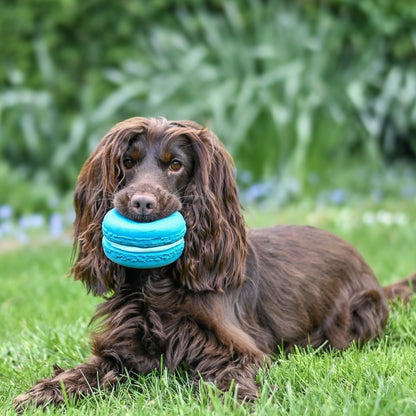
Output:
[0,202,416,416]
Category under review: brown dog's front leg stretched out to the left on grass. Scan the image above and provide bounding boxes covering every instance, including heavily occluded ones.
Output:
[14,295,160,412]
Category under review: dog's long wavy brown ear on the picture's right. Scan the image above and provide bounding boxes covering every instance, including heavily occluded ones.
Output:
[172,121,247,291]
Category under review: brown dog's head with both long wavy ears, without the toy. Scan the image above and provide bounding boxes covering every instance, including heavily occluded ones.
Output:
[72,117,246,294]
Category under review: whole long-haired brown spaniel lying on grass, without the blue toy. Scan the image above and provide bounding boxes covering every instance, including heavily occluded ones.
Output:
[15,117,416,411]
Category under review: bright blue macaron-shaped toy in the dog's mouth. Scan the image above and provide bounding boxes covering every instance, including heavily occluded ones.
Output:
[102,208,186,269]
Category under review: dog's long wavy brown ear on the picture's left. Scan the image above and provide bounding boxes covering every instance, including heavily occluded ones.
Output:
[71,117,148,295]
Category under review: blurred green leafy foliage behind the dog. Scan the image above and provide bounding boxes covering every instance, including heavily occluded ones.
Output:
[0,0,416,213]
